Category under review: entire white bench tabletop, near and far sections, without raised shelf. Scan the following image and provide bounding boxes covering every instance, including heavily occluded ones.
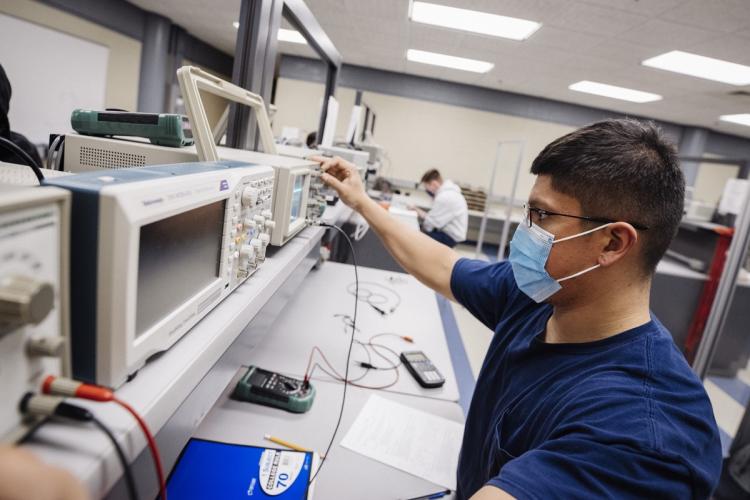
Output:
[195,262,464,500]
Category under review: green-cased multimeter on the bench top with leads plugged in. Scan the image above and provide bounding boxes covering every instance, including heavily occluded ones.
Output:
[232,366,315,413]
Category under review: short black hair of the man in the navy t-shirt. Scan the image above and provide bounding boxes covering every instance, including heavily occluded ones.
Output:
[531,119,685,275]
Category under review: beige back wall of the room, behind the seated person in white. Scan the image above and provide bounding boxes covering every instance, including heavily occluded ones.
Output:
[274,78,573,198]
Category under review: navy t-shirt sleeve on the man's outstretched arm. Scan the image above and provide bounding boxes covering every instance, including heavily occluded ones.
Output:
[451,259,517,330]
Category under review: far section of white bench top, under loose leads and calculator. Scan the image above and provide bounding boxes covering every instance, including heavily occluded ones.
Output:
[235,262,459,402]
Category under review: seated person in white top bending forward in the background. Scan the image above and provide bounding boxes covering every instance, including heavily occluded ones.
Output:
[412,168,469,248]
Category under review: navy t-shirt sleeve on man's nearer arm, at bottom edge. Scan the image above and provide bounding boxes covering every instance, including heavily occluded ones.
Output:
[488,437,696,500]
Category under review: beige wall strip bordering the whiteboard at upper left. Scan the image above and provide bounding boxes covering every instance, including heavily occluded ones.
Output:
[0,0,141,111]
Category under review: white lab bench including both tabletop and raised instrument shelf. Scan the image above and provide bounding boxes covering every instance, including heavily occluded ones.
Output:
[25,228,463,498]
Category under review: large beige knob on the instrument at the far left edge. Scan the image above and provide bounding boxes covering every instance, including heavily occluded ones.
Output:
[0,275,55,325]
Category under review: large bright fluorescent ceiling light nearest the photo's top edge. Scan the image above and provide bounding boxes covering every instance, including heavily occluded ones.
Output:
[409,2,542,40]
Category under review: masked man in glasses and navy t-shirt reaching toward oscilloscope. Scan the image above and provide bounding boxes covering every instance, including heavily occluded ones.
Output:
[319,120,721,500]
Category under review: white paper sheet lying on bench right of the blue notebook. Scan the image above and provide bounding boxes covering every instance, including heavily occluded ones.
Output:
[341,395,464,490]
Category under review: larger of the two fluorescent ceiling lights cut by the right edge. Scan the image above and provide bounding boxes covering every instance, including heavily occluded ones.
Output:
[641,50,750,85]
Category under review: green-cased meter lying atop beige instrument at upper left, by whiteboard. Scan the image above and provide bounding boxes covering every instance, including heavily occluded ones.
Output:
[70,109,194,147]
